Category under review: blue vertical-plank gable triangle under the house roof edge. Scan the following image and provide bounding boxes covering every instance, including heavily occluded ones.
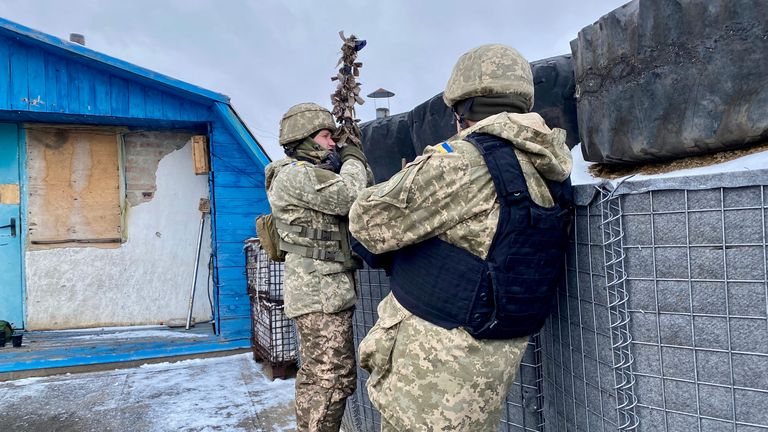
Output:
[0,36,211,121]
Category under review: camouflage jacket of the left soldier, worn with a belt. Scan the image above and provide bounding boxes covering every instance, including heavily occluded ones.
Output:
[265,158,368,318]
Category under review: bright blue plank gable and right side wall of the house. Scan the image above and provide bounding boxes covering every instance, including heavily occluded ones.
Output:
[0,25,269,347]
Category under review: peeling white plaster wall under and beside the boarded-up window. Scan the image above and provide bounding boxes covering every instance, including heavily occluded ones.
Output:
[26,142,212,330]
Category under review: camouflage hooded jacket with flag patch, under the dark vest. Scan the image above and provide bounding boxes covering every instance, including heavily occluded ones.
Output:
[350,113,572,258]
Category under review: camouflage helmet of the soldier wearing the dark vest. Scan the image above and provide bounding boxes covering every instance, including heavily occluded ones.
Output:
[443,44,533,109]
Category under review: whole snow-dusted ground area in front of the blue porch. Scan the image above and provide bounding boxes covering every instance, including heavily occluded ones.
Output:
[0,354,296,432]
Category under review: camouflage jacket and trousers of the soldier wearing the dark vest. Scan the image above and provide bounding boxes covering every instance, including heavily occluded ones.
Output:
[350,113,572,432]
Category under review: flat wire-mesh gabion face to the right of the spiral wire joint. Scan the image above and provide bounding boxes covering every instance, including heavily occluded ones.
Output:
[621,186,768,432]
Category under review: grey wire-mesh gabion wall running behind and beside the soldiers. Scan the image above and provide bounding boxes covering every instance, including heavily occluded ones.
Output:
[344,176,768,432]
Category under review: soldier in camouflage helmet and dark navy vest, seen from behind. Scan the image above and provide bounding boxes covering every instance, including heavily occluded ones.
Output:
[350,45,572,432]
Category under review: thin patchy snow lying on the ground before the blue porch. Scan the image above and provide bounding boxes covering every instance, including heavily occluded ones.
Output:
[0,353,296,432]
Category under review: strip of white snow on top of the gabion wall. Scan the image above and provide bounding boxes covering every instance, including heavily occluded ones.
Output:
[571,143,768,185]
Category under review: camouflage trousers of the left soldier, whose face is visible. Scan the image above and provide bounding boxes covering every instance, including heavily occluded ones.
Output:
[295,310,357,432]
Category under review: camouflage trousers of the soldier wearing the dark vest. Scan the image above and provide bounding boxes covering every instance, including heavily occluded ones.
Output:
[360,294,529,432]
